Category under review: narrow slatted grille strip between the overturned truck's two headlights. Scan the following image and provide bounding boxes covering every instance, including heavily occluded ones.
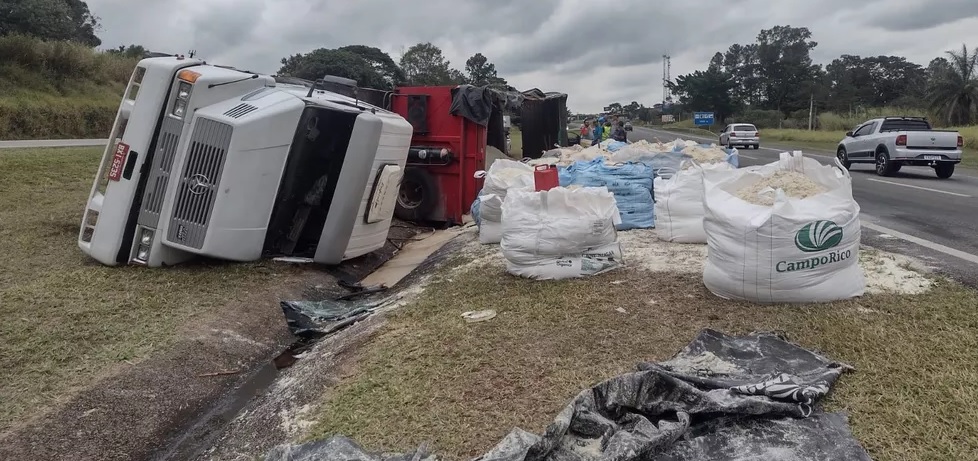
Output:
[139,117,183,229]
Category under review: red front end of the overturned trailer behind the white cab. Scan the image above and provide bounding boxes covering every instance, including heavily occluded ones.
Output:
[390,86,487,224]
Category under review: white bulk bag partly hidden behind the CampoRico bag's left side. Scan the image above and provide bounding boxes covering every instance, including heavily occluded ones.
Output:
[653,162,736,243]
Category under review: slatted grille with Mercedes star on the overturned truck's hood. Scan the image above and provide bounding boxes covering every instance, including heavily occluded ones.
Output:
[167,118,233,249]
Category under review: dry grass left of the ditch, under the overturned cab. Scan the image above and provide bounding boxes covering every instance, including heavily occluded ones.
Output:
[0,148,304,432]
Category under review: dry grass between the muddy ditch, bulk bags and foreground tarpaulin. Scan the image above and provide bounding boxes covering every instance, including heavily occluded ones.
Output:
[308,239,978,461]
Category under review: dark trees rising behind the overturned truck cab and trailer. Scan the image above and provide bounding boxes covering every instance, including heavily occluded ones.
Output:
[270,42,509,89]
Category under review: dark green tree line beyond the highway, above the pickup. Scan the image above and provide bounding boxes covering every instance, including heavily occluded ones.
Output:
[604,26,978,127]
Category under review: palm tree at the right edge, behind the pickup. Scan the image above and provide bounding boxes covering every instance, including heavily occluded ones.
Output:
[928,45,978,126]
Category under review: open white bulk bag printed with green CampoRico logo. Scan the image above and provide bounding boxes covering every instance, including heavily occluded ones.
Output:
[703,152,866,303]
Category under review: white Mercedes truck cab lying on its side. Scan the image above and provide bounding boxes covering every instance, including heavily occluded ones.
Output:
[78,56,412,267]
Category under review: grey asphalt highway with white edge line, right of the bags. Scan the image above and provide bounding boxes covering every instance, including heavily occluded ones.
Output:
[629,127,978,287]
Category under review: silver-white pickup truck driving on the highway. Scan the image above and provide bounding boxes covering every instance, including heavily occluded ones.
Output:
[836,117,964,179]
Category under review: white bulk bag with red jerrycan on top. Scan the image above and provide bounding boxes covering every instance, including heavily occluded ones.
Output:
[500,187,622,279]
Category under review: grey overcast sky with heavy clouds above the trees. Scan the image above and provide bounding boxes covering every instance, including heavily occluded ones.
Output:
[88,0,978,112]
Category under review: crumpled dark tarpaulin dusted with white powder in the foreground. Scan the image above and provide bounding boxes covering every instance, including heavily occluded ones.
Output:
[265,330,870,461]
